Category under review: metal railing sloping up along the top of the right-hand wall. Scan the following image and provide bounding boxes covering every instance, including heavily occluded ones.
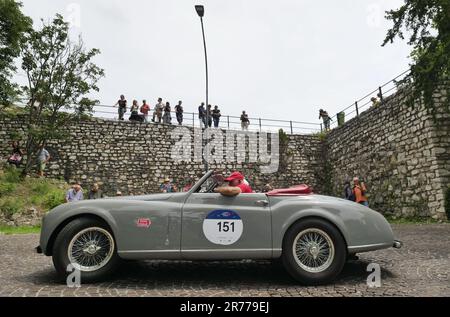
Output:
[324,69,410,129]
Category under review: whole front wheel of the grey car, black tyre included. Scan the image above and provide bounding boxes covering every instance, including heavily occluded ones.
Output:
[53,217,120,283]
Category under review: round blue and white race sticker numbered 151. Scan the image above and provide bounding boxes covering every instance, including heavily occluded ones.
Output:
[203,210,244,245]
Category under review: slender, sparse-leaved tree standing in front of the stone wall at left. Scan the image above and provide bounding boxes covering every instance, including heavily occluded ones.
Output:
[21,15,104,175]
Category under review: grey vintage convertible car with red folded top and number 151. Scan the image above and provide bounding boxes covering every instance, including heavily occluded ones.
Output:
[37,172,401,284]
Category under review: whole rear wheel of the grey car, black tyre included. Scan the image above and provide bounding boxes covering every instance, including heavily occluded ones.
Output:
[282,218,347,285]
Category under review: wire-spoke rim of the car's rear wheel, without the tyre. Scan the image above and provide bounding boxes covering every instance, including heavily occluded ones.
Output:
[292,228,335,273]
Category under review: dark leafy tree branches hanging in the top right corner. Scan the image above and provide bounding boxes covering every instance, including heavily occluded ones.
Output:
[383,0,450,109]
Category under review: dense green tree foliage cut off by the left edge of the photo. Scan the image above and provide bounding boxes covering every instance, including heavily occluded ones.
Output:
[0,0,33,105]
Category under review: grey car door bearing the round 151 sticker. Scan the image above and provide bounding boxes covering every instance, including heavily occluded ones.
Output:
[181,193,272,259]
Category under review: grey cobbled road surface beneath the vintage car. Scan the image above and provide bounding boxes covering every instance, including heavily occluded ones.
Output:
[0,224,450,297]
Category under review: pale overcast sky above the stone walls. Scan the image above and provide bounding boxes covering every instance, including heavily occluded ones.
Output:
[15,0,410,130]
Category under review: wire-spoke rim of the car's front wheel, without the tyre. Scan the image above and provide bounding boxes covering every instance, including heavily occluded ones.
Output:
[67,227,115,272]
